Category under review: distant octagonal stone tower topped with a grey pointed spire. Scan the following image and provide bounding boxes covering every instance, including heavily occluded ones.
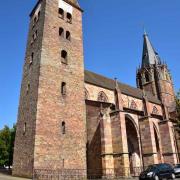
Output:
[137,33,175,113]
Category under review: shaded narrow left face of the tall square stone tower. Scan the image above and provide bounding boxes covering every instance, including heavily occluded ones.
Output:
[13,1,45,177]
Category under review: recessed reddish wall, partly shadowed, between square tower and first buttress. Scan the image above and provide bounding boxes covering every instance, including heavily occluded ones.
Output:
[86,101,102,176]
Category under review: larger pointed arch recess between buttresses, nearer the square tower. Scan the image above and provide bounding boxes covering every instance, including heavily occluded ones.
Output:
[125,115,141,174]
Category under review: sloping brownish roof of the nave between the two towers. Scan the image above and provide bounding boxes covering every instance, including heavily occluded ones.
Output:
[85,70,161,104]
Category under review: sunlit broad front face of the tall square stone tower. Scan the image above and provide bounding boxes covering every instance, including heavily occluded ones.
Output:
[34,0,86,172]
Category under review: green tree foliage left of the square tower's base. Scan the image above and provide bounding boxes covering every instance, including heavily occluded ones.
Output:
[0,125,16,167]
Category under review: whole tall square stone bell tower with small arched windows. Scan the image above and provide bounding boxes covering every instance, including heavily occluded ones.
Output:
[13,0,86,177]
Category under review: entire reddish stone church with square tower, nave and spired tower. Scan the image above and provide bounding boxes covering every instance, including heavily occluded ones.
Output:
[13,0,179,177]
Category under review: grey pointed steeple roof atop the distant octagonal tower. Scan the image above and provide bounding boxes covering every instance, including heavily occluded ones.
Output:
[142,31,161,67]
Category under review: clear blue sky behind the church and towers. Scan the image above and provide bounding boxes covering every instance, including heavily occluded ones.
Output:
[0,0,180,128]
